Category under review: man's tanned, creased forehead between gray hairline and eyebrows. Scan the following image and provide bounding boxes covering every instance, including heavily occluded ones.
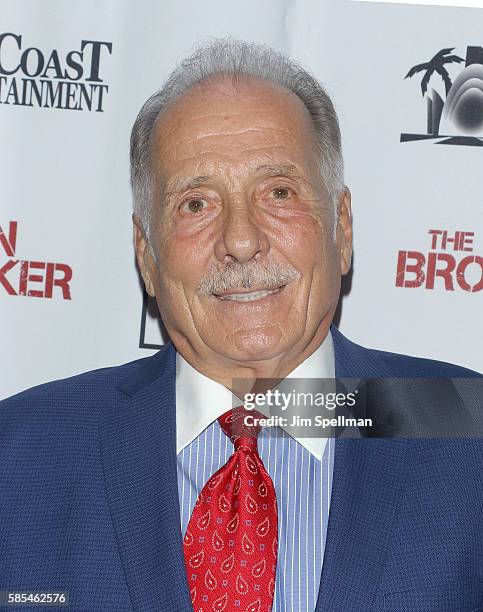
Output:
[147,74,317,192]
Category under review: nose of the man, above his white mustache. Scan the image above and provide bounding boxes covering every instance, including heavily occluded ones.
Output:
[215,202,269,263]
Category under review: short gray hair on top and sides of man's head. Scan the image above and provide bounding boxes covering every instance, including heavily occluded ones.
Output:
[131,38,344,246]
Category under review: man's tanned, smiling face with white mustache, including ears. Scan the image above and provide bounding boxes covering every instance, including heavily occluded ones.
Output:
[136,78,351,364]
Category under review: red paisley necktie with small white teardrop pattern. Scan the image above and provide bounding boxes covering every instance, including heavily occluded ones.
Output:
[184,406,278,612]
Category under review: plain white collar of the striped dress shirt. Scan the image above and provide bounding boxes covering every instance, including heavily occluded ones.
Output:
[176,331,335,460]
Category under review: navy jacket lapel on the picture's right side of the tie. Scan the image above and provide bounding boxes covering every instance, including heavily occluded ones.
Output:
[316,328,408,612]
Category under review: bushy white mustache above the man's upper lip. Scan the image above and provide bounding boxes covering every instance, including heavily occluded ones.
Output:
[198,261,301,295]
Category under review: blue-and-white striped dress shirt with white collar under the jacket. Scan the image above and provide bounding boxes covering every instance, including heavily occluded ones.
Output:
[176,332,335,612]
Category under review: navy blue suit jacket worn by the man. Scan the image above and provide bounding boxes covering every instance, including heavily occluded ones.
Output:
[0,328,483,612]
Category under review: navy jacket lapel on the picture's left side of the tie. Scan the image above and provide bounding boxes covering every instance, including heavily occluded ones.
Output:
[100,344,193,612]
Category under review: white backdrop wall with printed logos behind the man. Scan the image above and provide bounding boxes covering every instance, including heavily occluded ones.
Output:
[0,0,483,397]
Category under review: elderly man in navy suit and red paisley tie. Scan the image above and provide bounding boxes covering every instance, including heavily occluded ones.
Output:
[0,40,483,612]
